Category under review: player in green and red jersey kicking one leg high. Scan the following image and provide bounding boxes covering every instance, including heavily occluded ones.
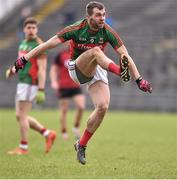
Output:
[9,1,152,164]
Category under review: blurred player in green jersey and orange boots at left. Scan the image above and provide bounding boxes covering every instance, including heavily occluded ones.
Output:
[8,18,56,155]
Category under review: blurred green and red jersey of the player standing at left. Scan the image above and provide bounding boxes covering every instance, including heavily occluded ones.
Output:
[18,37,46,85]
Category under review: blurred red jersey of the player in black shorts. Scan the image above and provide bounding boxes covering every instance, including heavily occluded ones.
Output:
[54,51,80,88]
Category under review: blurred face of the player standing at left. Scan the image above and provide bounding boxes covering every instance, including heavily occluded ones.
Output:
[24,24,38,39]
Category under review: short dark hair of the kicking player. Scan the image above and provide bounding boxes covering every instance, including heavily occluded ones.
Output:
[86,1,105,16]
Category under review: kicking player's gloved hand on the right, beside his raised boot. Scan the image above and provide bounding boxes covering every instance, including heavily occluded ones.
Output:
[136,76,152,93]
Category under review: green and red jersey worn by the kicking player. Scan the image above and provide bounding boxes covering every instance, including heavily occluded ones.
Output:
[57,19,123,60]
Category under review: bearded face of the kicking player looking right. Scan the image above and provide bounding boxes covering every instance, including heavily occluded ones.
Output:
[88,8,106,29]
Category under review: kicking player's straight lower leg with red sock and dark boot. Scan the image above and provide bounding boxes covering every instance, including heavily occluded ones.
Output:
[74,81,110,164]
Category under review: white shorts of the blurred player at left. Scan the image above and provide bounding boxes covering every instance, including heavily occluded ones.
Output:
[15,83,38,102]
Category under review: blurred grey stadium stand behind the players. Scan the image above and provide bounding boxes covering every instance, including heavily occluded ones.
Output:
[0,0,177,112]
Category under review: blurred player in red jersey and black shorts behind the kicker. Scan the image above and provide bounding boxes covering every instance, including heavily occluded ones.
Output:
[50,45,85,139]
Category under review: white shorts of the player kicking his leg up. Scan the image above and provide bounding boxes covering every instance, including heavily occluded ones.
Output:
[68,61,108,86]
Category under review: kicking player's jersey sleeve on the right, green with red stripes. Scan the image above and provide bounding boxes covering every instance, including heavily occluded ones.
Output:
[105,25,123,49]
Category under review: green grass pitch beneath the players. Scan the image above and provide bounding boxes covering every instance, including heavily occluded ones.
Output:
[0,110,177,179]
